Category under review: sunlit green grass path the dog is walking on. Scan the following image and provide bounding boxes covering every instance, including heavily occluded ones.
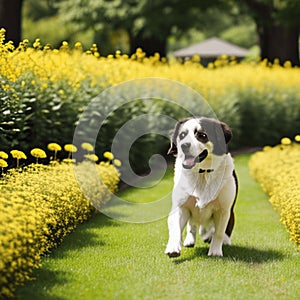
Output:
[17,155,300,300]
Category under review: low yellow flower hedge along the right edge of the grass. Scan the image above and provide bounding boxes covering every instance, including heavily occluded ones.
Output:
[249,136,300,249]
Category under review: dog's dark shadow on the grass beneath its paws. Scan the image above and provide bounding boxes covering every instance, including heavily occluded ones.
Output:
[174,245,285,264]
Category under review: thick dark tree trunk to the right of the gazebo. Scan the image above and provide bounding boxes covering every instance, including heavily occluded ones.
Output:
[257,22,300,66]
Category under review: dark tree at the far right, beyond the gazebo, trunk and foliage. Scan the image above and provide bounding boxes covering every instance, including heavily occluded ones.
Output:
[241,0,300,65]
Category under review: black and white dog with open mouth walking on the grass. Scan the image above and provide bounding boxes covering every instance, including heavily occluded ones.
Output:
[165,117,238,257]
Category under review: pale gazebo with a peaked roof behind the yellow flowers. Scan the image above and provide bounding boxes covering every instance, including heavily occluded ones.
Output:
[173,37,249,65]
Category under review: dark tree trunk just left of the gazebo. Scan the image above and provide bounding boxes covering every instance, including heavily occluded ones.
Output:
[130,35,167,57]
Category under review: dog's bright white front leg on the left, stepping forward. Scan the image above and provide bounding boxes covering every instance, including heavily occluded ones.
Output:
[165,207,189,257]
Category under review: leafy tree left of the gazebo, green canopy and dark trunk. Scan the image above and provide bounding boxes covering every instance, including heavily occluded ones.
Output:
[56,0,228,56]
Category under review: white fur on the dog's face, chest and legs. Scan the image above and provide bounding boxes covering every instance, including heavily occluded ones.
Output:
[165,119,236,257]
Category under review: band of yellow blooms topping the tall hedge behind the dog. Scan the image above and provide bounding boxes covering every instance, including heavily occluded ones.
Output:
[0,29,300,99]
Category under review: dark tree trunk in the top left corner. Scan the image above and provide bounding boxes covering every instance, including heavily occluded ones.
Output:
[0,0,23,46]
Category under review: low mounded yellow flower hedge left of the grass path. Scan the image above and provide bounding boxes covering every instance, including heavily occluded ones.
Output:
[0,155,119,299]
